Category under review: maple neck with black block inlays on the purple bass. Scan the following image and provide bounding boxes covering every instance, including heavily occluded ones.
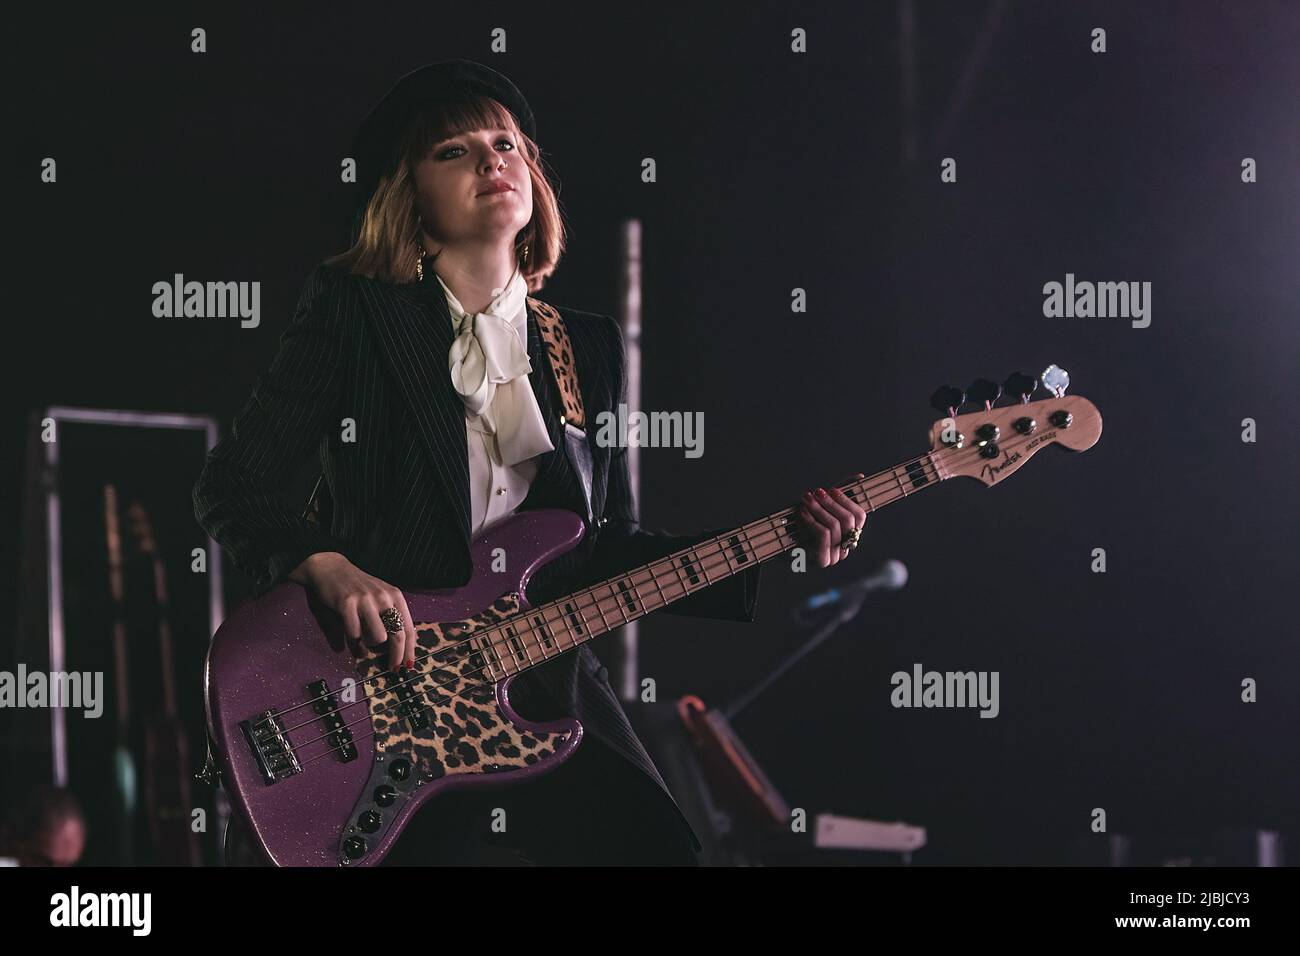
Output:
[473,454,949,680]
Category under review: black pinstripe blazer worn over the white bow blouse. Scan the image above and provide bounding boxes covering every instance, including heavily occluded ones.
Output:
[194,264,762,847]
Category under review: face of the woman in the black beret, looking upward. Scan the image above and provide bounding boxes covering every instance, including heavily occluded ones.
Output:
[415,130,533,254]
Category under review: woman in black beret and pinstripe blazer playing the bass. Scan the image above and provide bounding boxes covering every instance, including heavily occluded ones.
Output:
[194,60,866,864]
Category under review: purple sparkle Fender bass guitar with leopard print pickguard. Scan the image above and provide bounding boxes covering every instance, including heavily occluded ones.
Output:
[204,379,1101,866]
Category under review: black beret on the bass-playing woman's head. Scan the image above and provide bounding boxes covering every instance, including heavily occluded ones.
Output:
[352,60,537,242]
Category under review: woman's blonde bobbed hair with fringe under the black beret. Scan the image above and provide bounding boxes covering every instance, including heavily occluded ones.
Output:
[325,96,566,293]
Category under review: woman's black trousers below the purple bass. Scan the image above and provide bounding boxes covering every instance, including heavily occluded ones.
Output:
[381,735,697,866]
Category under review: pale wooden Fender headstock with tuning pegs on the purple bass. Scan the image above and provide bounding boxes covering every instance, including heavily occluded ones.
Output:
[930,365,1101,485]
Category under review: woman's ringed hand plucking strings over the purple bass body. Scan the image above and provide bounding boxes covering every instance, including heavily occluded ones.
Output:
[289,551,416,670]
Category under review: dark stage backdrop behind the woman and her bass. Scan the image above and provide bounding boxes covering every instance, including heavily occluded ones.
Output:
[0,3,1300,864]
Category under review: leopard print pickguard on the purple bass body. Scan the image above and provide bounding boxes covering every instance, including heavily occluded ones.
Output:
[364,594,572,779]
